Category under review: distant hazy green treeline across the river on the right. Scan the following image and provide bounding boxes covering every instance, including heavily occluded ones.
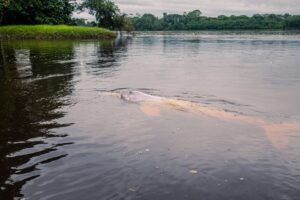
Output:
[130,10,300,31]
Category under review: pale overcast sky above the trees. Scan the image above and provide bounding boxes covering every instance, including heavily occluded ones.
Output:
[75,0,300,19]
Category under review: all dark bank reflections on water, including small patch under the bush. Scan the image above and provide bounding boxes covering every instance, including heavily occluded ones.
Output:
[0,38,129,199]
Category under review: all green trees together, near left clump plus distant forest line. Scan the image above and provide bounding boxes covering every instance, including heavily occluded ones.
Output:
[0,0,300,31]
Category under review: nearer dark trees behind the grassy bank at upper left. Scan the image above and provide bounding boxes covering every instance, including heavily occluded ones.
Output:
[0,0,130,30]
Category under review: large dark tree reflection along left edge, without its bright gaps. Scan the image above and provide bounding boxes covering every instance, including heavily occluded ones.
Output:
[0,42,73,199]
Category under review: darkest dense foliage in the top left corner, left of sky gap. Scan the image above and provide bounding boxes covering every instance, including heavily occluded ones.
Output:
[0,0,74,24]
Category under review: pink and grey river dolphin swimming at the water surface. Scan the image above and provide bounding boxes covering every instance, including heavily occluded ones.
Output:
[102,90,300,149]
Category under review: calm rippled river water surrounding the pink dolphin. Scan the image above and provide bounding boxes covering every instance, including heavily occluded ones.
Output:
[0,33,300,200]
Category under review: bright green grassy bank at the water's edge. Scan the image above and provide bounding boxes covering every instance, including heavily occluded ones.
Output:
[0,25,115,39]
